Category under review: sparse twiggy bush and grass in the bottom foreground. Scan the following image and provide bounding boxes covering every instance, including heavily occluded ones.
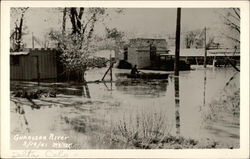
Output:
[111,110,221,149]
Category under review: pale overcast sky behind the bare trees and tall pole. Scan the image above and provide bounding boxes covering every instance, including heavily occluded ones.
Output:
[11,8,230,47]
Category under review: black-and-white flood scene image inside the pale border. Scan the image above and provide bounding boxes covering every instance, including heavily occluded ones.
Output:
[1,2,249,157]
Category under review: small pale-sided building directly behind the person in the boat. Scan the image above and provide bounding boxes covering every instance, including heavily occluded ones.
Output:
[119,38,168,68]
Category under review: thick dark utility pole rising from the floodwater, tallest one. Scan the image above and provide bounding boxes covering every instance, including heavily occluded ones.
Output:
[174,8,181,76]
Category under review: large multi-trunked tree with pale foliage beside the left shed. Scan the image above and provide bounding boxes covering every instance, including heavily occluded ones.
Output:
[50,7,105,81]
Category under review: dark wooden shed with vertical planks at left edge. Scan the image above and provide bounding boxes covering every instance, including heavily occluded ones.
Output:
[10,49,57,80]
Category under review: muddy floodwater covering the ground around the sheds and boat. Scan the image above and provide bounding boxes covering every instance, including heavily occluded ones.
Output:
[11,68,240,149]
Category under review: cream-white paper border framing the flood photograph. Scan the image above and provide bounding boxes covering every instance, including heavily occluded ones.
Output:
[1,1,249,158]
